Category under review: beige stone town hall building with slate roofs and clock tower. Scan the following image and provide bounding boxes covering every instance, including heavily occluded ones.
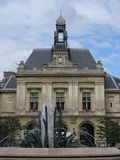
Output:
[0,15,120,145]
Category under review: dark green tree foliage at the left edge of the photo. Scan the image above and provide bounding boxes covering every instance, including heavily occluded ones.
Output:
[0,116,21,139]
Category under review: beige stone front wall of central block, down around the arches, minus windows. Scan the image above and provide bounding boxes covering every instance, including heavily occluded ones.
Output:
[16,76,105,134]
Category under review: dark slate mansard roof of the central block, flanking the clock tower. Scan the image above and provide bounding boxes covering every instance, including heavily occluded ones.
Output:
[25,48,96,70]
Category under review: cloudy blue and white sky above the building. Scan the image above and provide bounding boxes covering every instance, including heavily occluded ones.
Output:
[0,0,120,79]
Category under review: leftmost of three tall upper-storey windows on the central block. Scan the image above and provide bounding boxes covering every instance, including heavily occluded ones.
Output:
[30,91,38,111]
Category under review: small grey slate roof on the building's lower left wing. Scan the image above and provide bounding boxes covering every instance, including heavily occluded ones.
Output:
[0,76,16,90]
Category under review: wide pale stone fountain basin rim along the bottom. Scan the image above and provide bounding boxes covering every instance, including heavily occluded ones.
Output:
[0,147,120,160]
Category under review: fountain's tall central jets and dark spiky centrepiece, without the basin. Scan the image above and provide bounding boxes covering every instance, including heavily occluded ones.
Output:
[19,106,82,148]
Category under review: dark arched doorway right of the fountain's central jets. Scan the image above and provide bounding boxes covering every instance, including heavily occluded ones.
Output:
[80,122,95,146]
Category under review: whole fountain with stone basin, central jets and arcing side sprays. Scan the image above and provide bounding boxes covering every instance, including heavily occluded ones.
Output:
[0,106,120,160]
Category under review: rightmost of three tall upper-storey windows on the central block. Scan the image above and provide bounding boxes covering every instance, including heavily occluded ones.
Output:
[82,92,91,111]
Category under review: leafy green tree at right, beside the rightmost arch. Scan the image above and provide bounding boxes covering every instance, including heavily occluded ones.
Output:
[97,117,120,146]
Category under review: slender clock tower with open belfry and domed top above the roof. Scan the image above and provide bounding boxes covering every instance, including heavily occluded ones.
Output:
[52,15,70,66]
